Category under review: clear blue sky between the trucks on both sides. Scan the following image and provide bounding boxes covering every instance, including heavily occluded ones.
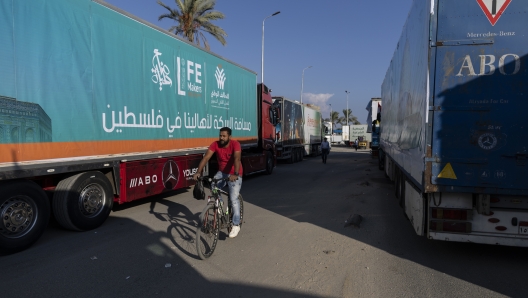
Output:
[106,0,413,124]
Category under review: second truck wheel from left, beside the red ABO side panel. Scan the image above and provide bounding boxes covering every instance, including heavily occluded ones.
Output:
[52,172,114,231]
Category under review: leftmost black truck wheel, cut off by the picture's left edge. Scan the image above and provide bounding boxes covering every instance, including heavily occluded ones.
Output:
[0,180,50,253]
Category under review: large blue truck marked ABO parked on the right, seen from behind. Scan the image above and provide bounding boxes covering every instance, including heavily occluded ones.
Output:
[380,0,528,246]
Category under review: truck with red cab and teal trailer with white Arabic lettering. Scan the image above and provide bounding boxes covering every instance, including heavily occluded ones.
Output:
[0,0,276,252]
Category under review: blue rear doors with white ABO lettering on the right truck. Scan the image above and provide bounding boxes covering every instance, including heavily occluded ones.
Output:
[429,0,528,189]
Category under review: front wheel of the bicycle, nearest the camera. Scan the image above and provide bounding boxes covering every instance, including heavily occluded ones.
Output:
[196,204,220,260]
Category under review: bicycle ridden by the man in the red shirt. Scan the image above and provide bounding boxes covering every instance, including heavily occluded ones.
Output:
[196,177,244,260]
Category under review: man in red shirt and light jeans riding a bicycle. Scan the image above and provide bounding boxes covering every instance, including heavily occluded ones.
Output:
[193,127,243,238]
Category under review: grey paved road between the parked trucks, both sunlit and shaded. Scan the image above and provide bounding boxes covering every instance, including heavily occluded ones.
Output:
[0,147,528,297]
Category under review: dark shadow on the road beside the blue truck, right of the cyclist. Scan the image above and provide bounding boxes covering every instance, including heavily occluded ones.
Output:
[244,147,528,297]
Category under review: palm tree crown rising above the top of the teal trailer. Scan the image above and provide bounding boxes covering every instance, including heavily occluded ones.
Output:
[158,0,227,50]
